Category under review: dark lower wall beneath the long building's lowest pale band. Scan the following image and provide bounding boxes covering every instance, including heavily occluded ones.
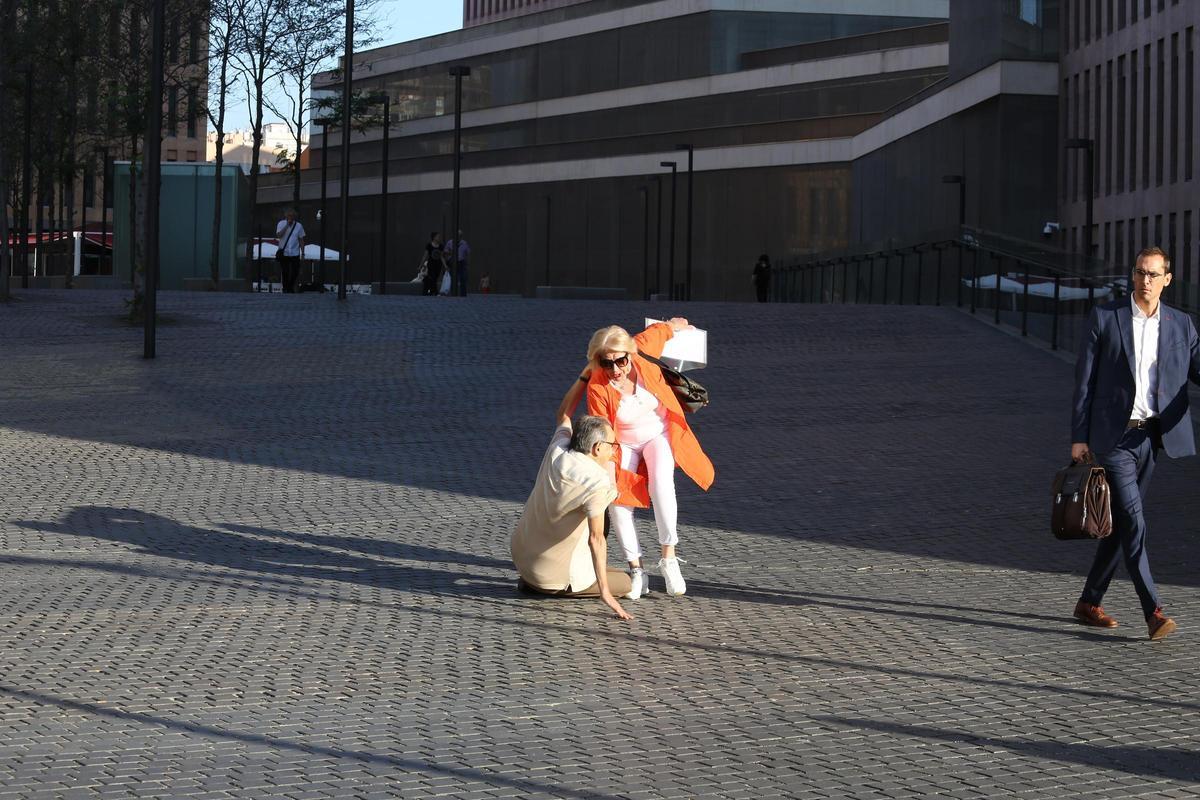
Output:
[256,164,851,300]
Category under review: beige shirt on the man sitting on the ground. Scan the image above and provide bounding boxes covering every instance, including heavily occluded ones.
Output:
[512,426,617,591]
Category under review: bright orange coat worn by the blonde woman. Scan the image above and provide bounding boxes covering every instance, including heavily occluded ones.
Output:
[588,323,716,509]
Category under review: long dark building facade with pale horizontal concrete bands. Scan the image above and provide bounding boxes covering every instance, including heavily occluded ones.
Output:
[258,0,949,299]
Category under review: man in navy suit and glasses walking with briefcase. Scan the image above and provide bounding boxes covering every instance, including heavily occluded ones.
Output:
[1070,247,1200,639]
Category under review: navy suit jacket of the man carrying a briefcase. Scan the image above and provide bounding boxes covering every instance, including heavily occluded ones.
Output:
[1070,297,1200,458]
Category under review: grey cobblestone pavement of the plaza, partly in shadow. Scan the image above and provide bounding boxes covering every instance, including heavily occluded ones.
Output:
[0,291,1200,800]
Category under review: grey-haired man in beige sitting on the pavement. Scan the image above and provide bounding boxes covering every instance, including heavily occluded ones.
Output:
[512,415,632,619]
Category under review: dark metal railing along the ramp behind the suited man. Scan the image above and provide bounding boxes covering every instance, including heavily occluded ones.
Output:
[770,228,1200,357]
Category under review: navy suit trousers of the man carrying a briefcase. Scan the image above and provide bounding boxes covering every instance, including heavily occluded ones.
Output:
[1080,429,1159,616]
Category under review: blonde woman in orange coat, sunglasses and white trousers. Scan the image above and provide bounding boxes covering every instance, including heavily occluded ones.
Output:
[559,317,714,600]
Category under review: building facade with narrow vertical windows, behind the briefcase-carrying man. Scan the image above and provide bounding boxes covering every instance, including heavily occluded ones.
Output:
[1058,0,1200,307]
